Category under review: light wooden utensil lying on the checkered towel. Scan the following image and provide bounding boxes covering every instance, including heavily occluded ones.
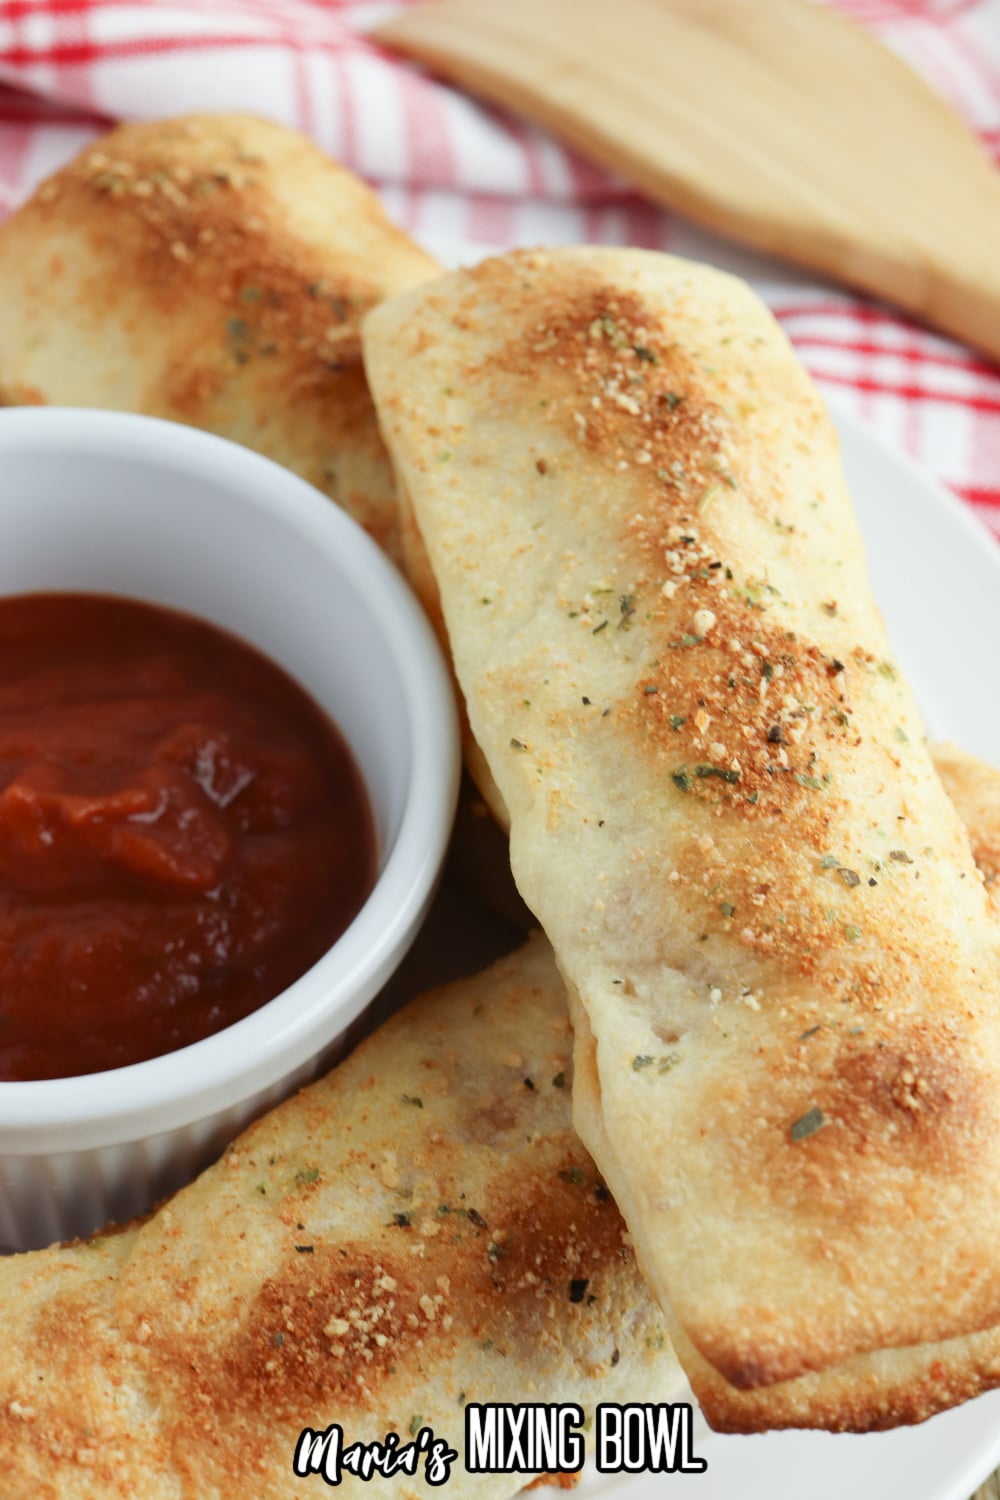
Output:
[375,0,1000,359]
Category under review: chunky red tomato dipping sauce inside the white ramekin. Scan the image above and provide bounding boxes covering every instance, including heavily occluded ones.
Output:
[0,594,375,1080]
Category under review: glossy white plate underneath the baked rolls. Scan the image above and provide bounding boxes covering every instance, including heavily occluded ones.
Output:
[429,242,1000,1500]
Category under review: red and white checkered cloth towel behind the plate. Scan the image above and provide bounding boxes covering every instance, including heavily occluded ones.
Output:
[0,0,1000,537]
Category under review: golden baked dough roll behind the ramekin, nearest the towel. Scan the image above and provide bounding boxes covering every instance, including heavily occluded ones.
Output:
[0,114,436,555]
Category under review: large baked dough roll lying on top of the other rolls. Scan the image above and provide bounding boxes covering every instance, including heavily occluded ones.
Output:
[364,249,1000,1427]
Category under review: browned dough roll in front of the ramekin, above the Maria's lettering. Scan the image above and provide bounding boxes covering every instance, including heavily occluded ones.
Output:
[0,938,682,1500]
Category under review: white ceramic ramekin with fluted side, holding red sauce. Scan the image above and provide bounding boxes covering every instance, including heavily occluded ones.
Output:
[0,408,459,1250]
